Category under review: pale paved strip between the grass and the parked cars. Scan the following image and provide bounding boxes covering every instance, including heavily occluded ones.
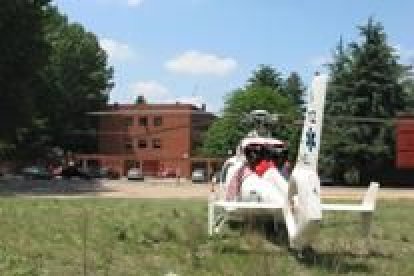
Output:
[0,179,414,200]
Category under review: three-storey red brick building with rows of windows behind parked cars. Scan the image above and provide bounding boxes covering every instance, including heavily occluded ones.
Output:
[77,103,221,177]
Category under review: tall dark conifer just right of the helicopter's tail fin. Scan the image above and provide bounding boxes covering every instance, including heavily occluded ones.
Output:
[323,18,407,184]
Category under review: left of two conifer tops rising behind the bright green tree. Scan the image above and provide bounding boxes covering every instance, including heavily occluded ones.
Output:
[247,64,283,92]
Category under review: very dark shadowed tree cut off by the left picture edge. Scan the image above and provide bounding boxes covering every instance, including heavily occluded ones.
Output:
[0,0,49,156]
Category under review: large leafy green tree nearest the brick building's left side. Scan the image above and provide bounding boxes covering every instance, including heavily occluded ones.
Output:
[36,8,113,151]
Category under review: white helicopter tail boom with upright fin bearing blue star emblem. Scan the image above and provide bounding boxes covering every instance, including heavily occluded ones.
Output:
[284,75,327,248]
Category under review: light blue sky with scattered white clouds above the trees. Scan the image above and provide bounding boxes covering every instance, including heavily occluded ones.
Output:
[53,0,414,112]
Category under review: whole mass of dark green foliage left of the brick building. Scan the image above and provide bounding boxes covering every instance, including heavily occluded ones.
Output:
[0,0,113,159]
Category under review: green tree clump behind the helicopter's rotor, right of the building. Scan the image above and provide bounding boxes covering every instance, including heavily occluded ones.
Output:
[201,65,304,158]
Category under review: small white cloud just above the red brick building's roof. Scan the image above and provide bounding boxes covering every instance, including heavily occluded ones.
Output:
[130,80,171,101]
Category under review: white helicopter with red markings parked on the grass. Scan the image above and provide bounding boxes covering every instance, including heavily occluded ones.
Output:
[208,74,379,249]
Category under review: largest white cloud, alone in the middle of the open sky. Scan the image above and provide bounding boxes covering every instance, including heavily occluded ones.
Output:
[165,50,237,76]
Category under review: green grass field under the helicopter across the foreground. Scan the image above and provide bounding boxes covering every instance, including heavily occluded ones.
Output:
[0,198,414,275]
